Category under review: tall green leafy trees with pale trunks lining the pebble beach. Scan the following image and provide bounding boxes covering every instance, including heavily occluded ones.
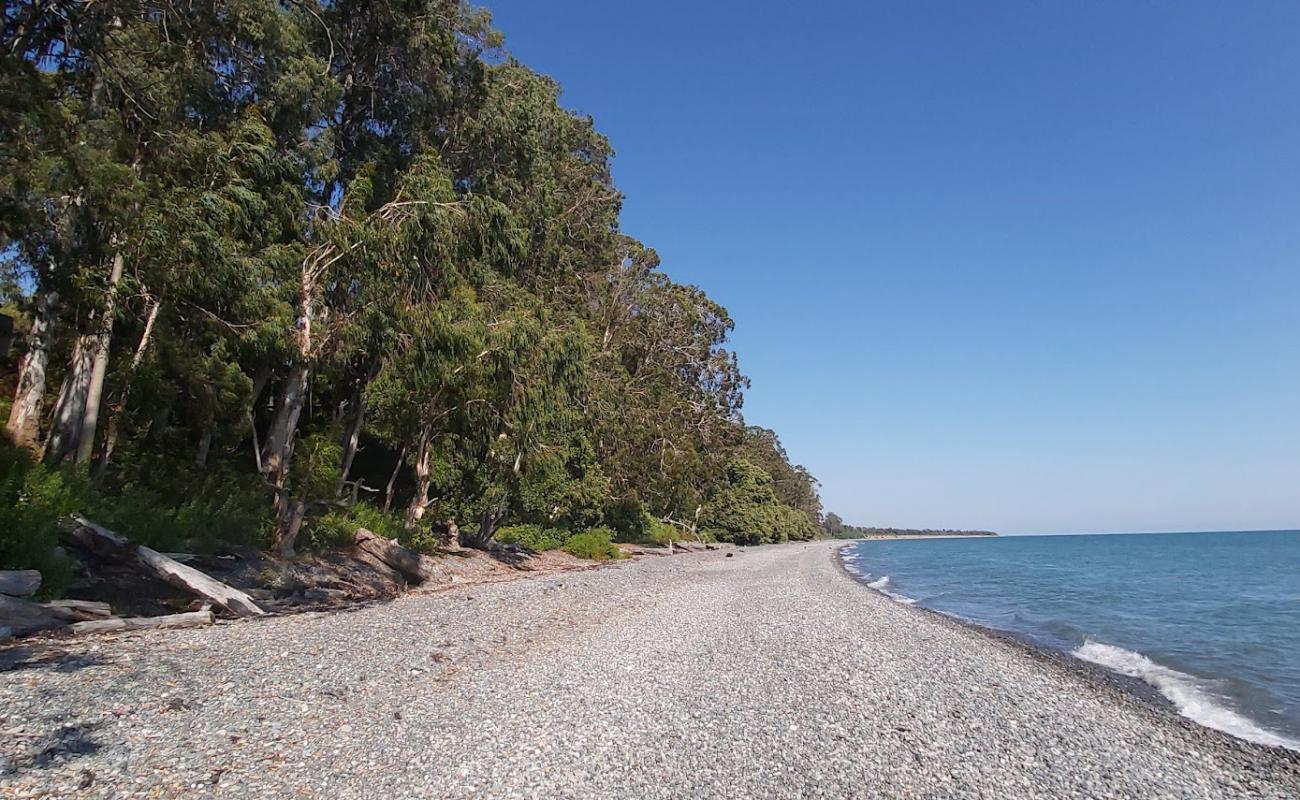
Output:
[0,0,822,566]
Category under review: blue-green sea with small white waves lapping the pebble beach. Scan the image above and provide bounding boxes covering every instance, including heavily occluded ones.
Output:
[842,531,1300,751]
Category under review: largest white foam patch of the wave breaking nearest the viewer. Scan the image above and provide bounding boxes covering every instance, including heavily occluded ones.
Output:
[1074,639,1300,751]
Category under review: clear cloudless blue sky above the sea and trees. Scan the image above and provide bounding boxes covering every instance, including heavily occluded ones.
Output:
[489,0,1300,532]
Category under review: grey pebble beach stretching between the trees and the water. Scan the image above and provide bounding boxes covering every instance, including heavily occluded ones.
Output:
[0,542,1300,800]
